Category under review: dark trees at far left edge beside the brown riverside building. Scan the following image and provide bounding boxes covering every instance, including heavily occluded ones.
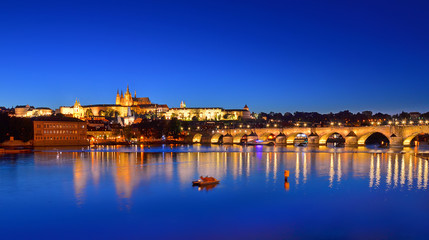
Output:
[0,113,33,142]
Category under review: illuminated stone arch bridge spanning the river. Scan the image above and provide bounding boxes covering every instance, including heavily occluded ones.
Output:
[187,125,429,146]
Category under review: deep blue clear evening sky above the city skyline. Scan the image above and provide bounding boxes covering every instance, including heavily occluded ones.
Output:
[0,0,429,113]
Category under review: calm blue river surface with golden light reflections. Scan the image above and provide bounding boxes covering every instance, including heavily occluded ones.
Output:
[0,143,429,239]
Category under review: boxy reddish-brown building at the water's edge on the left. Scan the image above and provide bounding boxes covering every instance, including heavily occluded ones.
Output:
[33,116,89,147]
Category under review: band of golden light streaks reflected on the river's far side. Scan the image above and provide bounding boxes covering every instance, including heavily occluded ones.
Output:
[30,148,429,208]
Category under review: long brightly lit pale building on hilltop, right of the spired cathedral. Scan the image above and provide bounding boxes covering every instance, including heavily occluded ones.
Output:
[164,102,252,121]
